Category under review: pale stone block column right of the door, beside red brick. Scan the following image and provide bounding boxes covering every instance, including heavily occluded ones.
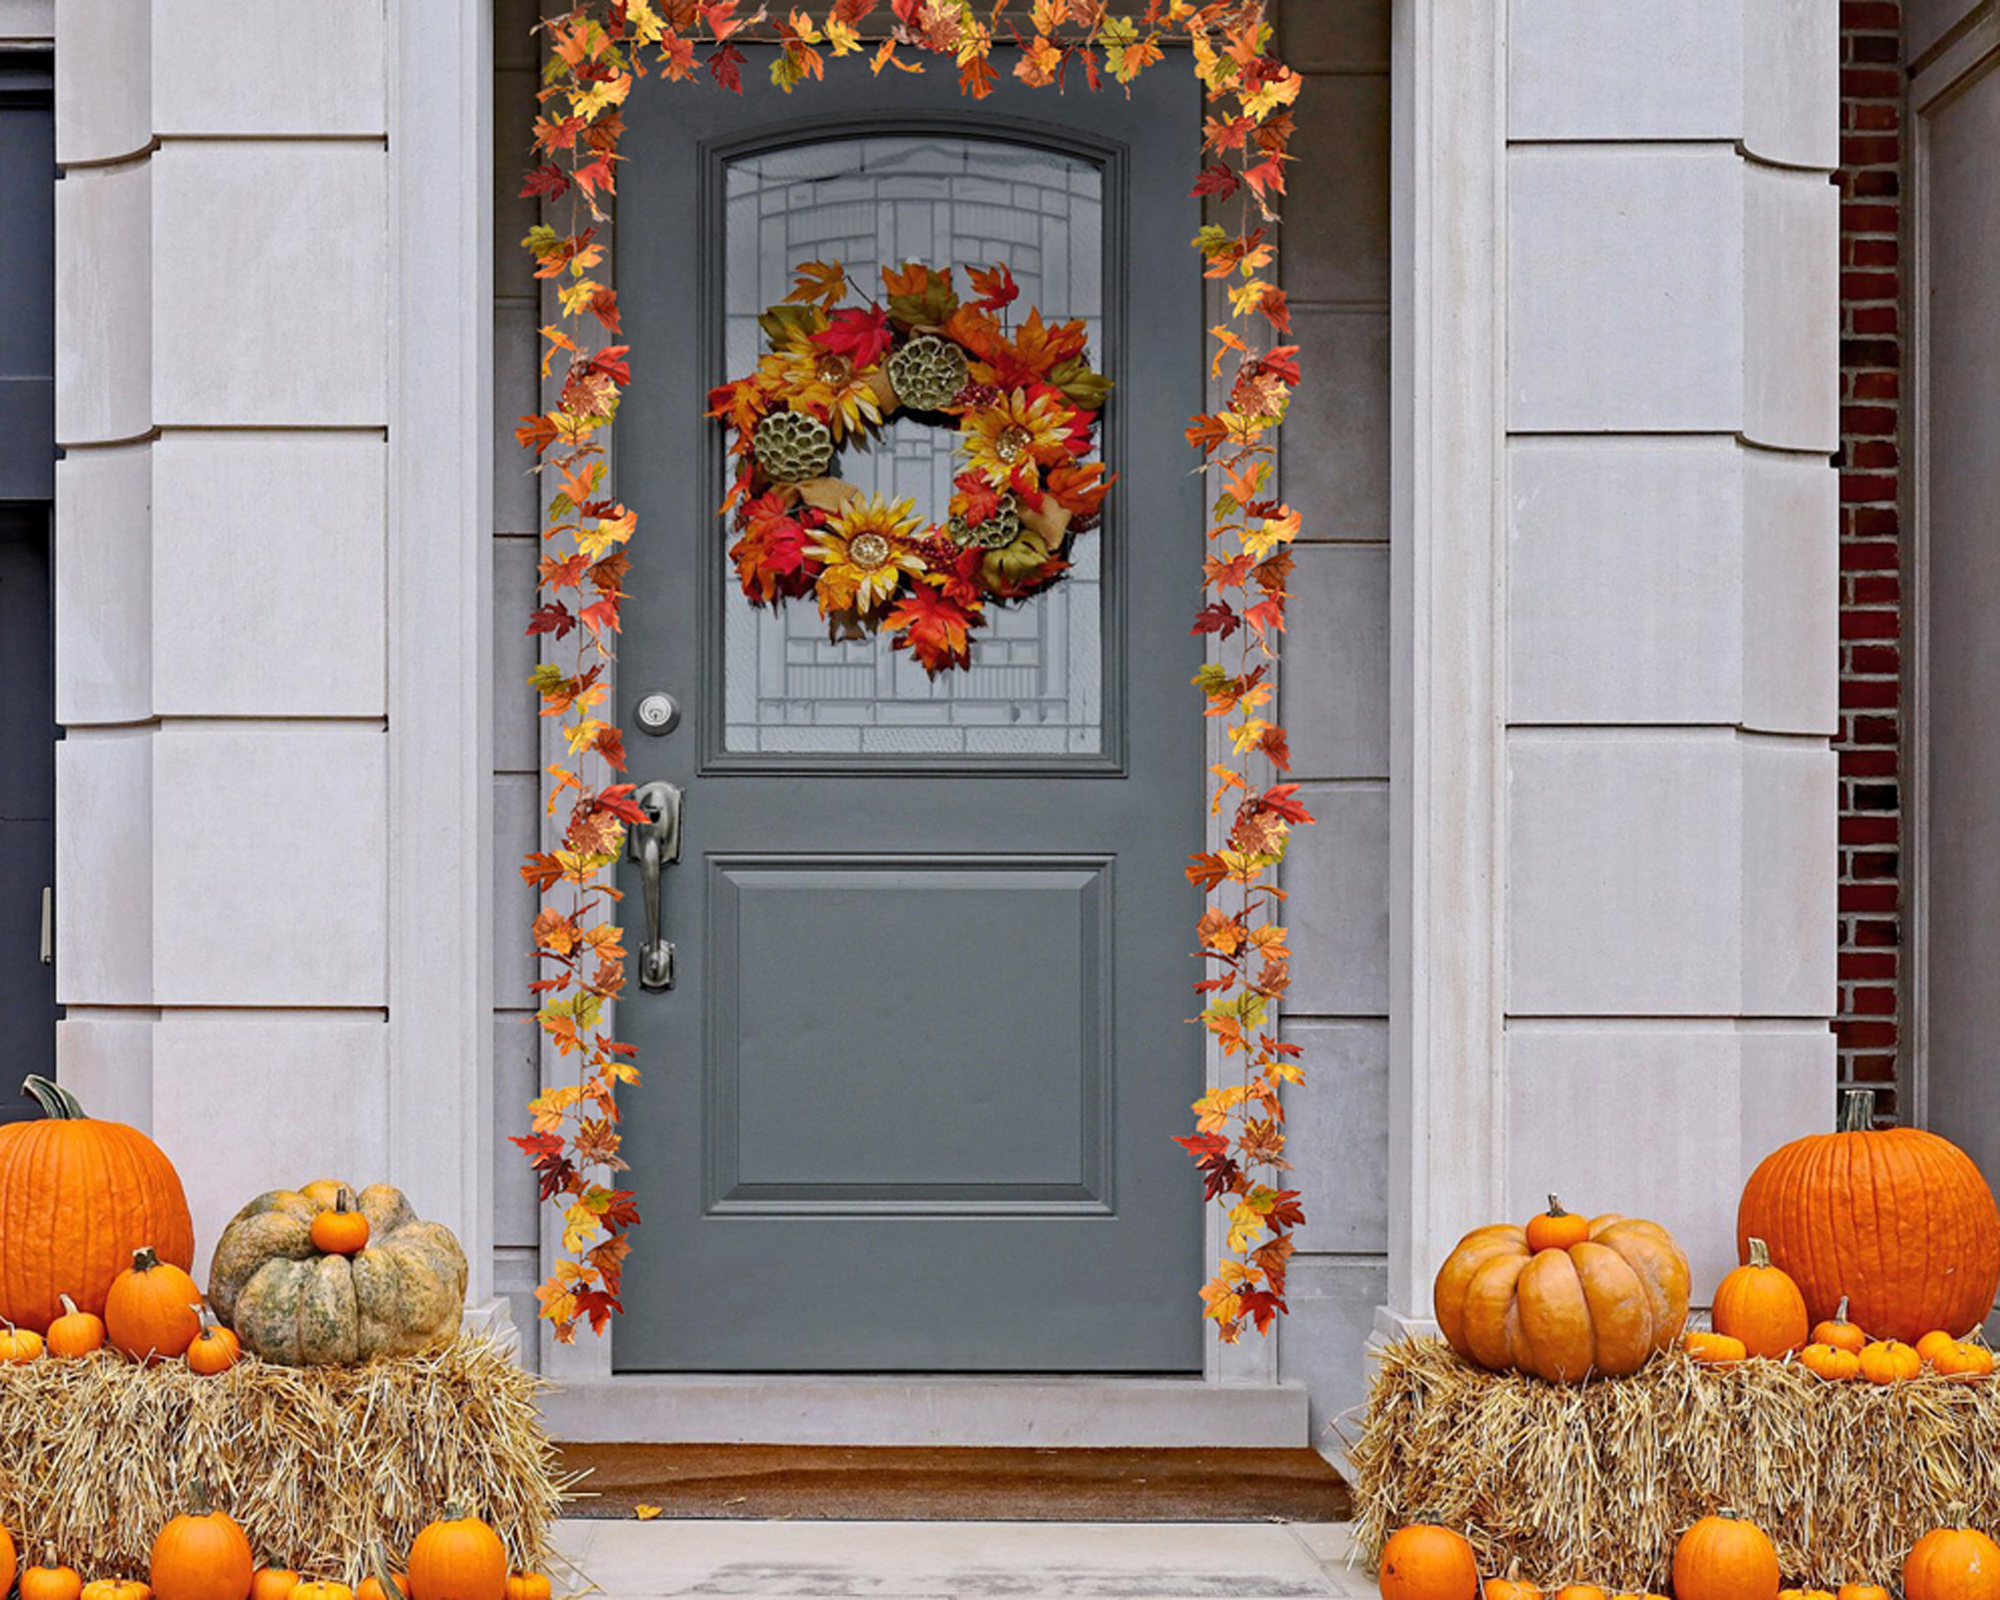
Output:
[1386,0,1838,1326]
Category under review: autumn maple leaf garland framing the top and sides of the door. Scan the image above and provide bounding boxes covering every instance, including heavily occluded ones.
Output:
[514,0,1312,1342]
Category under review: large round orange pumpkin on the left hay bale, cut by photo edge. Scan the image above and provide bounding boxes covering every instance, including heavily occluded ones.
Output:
[0,1078,194,1334]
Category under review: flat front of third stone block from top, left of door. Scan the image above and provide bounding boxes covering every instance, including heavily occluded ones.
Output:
[152,434,386,716]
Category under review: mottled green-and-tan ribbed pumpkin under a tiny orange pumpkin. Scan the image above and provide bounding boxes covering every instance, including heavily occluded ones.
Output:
[208,1180,466,1366]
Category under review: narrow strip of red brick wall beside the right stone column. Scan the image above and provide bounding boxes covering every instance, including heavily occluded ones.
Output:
[1834,0,1904,1114]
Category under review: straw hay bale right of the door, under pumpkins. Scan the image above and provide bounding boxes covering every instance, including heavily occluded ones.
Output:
[1350,1338,2000,1592]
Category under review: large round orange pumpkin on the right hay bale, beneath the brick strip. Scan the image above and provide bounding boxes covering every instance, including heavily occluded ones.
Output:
[1736,1088,2000,1344]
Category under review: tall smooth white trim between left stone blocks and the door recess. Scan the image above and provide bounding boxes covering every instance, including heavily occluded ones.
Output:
[388,0,494,1314]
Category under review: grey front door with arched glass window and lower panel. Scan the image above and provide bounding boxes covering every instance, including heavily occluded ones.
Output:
[616,56,1204,1372]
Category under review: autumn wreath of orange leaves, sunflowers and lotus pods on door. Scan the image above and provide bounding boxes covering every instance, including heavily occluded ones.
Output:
[708,262,1114,676]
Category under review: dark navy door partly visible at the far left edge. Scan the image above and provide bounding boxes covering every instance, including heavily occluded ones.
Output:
[0,56,56,1122]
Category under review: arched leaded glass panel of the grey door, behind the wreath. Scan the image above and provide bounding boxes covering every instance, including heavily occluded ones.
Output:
[718,134,1116,756]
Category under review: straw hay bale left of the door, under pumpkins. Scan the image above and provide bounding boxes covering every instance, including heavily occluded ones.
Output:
[0,1334,576,1582]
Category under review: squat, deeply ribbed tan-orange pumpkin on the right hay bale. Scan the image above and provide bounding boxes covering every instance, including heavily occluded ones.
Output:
[1432,1216,1688,1384]
